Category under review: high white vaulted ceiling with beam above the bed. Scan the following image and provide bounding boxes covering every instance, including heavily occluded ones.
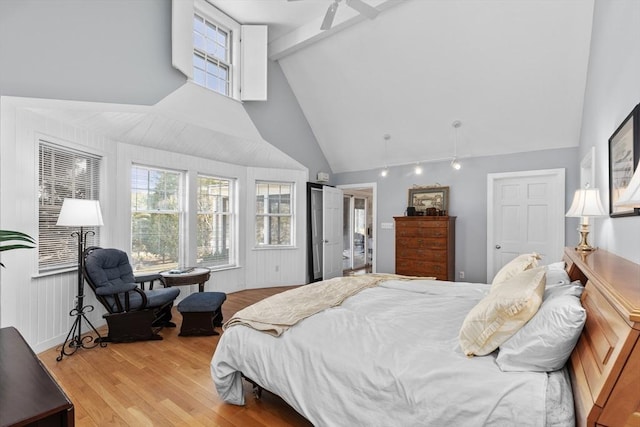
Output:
[210,0,593,173]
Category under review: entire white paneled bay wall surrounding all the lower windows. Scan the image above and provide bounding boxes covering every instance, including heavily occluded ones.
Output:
[0,97,308,352]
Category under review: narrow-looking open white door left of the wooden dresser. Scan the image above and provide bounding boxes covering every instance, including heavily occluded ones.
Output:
[322,186,342,280]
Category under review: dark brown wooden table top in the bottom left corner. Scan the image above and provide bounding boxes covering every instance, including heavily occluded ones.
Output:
[0,327,74,427]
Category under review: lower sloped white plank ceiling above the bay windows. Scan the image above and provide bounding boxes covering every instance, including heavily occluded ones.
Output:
[21,82,304,170]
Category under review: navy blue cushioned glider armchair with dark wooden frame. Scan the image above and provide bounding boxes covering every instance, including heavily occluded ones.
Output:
[83,246,180,342]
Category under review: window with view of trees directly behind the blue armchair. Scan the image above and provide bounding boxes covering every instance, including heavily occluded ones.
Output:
[131,166,184,271]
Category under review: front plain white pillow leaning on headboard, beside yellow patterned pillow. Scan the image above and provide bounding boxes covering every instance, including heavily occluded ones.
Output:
[496,294,587,372]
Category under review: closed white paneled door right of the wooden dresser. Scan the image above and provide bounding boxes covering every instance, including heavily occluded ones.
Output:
[487,169,565,283]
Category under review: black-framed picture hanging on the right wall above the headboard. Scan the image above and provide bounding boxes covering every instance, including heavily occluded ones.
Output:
[609,104,640,218]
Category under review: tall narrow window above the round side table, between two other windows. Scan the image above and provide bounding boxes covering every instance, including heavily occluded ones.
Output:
[197,175,236,268]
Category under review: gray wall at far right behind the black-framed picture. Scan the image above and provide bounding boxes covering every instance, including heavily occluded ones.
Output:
[580,0,640,263]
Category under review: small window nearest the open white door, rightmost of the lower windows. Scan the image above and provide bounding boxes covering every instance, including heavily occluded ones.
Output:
[256,181,293,246]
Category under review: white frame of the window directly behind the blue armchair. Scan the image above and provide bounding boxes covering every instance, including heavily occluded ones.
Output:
[129,163,188,272]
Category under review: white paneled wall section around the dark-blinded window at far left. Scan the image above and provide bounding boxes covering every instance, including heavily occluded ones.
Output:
[0,98,116,351]
